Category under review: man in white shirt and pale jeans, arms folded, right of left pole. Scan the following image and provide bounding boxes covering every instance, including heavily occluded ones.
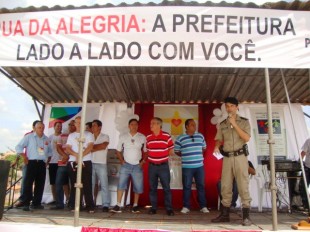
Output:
[92,120,110,212]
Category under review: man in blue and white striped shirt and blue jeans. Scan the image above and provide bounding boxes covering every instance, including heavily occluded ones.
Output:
[174,119,209,213]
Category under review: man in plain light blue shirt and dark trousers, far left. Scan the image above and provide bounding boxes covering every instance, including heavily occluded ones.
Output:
[16,121,52,211]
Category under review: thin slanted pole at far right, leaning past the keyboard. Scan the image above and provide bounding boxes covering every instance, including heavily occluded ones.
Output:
[280,69,310,209]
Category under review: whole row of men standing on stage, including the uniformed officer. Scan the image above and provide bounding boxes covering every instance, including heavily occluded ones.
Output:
[16,98,251,225]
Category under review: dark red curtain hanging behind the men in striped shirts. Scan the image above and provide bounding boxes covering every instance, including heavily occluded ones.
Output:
[131,104,222,209]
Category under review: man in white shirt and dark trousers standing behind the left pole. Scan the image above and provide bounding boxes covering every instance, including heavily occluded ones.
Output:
[66,116,95,213]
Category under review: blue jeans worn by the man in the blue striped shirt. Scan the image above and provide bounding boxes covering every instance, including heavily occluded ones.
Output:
[182,166,207,209]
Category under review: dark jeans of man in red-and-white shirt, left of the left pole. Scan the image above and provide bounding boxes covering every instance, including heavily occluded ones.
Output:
[55,166,69,208]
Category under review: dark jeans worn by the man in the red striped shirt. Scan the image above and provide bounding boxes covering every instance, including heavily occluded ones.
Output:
[149,162,172,210]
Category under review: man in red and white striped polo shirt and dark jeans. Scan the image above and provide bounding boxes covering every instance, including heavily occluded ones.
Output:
[146,117,174,216]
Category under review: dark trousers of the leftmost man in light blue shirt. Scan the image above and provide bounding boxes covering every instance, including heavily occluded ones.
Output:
[24,160,46,206]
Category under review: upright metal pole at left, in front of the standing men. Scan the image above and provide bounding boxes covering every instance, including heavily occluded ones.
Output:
[74,66,90,227]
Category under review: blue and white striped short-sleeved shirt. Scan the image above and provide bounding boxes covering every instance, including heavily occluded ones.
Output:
[174,133,207,168]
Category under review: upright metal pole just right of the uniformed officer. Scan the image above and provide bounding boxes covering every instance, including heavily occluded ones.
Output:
[265,68,278,231]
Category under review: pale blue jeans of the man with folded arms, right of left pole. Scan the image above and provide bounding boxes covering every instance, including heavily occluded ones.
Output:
[92,163,111,207]
